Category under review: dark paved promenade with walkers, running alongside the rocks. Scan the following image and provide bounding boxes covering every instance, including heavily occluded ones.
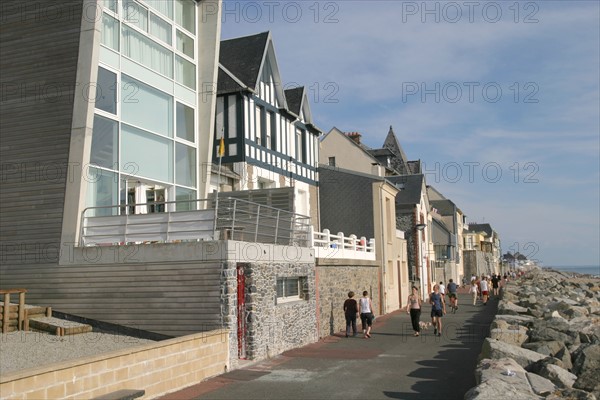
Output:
[164,294,497,400]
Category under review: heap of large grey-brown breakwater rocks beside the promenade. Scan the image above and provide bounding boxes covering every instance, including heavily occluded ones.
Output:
[465,269,600,400]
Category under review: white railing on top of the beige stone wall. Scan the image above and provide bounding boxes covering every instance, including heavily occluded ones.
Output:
[310,229,375,261]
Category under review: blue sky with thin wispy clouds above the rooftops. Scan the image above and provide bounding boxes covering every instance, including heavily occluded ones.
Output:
[221,0,600,268]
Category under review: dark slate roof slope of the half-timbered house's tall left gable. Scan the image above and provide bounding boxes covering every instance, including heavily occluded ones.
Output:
[217,32,269,89]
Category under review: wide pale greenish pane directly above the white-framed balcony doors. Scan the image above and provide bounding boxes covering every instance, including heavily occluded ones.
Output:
[121,124,173,182]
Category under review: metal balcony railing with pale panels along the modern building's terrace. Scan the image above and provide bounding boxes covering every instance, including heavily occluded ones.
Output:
[80,198,310,247]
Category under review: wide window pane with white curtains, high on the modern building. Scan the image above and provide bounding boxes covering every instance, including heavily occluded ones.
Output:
[123,25,173,78]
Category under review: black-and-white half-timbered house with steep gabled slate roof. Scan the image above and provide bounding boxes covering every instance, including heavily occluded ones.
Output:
[211,32,321,227]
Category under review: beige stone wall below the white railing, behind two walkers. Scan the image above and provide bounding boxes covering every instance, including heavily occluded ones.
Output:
[317,259,381,338]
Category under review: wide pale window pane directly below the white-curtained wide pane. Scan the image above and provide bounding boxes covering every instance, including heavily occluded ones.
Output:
[121,74,173,137]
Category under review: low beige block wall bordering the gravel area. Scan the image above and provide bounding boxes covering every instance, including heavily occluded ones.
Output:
[0,330,229,400]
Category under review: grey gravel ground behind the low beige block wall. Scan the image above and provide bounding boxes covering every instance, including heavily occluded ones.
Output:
[0,332,153,375]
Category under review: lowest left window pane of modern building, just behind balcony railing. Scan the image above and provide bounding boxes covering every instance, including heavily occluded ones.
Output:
[85,168,119,217]
